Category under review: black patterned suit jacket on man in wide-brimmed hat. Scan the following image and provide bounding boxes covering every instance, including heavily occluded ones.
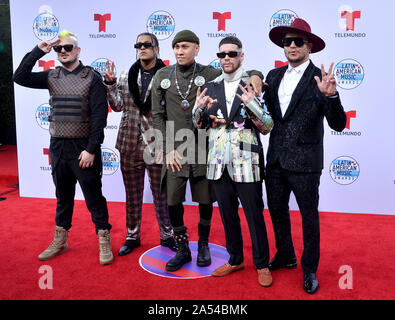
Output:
[264,61,347,172]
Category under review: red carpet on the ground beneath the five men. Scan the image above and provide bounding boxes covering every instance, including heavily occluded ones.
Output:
[0,145,395,300]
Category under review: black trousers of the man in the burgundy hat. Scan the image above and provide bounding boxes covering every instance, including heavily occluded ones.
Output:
[265,163,321,273]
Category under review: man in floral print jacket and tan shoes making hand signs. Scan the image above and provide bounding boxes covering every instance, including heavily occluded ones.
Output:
[193,37,273,287]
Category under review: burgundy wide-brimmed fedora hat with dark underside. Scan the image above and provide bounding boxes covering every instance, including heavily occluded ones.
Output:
[269,18,325,53]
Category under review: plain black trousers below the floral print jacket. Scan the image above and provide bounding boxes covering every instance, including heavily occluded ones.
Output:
[211,169,269,269]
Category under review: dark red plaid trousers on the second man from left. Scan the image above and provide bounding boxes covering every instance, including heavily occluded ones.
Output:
[121,139,173,240]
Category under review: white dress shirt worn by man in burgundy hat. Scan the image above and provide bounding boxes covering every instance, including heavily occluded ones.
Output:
[278,60,310,117]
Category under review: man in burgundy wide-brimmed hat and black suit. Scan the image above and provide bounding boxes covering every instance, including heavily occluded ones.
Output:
[265,18,346,294]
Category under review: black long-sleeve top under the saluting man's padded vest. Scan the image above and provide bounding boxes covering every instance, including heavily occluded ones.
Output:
[13,46,108,159]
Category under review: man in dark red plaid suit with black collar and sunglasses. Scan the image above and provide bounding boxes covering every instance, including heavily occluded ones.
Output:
[104,33,176,256]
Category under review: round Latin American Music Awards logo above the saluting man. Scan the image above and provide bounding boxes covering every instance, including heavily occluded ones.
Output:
[33,6,59,41]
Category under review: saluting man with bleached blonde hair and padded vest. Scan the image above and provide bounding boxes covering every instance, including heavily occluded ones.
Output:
[14,30,114,264]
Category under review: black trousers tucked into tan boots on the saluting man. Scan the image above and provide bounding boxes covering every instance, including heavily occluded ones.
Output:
[51,153,111,232]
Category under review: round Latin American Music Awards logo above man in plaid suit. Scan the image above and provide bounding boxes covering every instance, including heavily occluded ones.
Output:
[147,11,176,40]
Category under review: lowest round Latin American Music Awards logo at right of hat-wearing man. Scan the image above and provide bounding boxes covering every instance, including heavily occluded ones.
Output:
[329,156,360,185]
